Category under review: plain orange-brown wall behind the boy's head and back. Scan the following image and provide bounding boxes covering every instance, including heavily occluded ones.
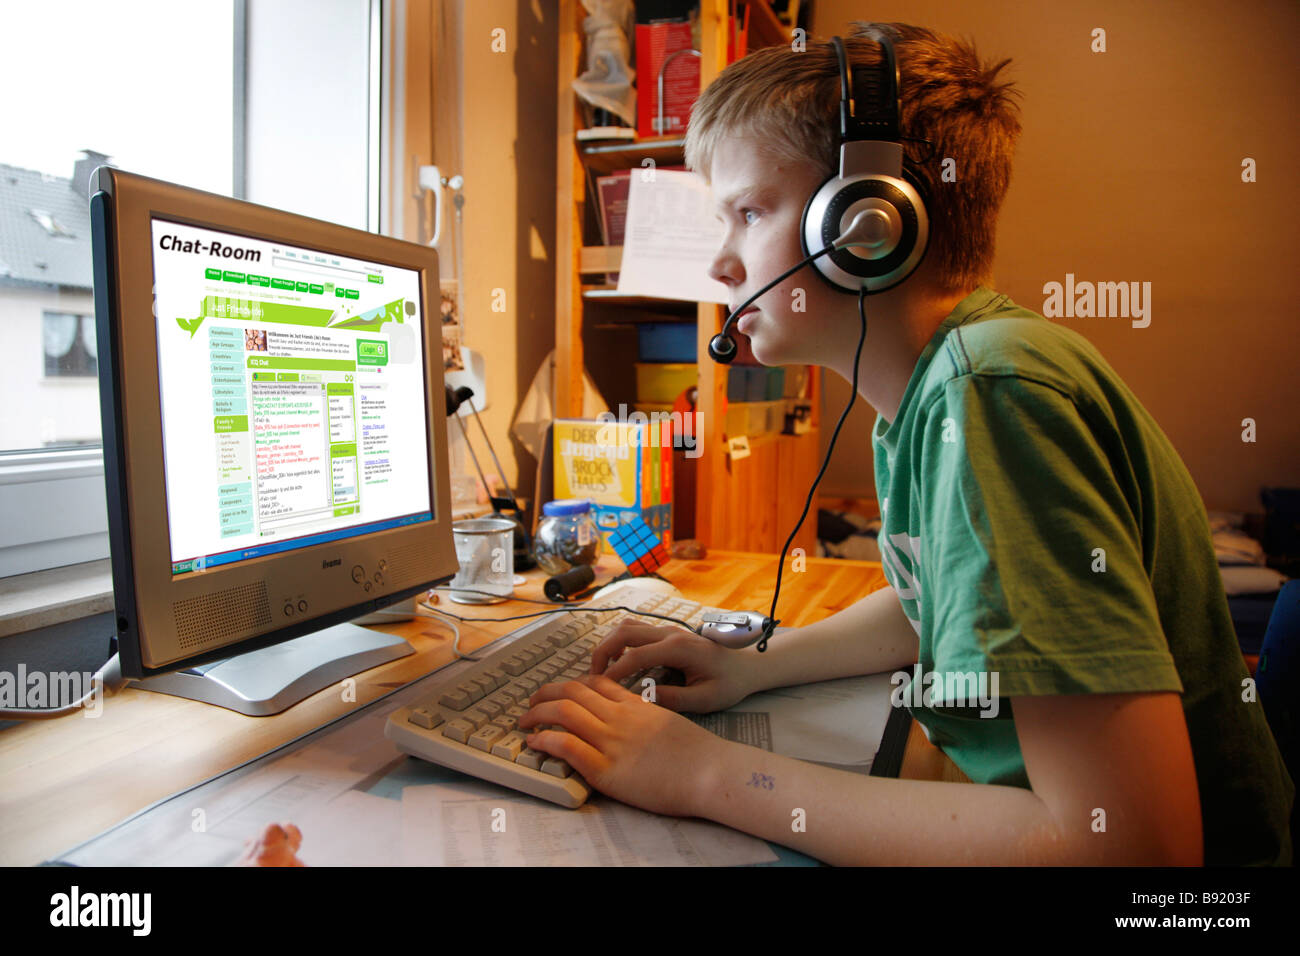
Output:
[811,0,1300,511]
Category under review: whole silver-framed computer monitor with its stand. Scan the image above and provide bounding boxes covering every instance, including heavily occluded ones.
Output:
[91,166,456,714]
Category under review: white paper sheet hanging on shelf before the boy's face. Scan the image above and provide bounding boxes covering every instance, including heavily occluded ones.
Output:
[619,169,728,303]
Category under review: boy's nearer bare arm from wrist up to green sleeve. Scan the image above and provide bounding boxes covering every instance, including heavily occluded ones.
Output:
[694,693,1203,866]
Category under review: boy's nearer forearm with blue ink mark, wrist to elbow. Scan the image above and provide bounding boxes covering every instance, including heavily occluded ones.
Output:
[693,741,1102,866]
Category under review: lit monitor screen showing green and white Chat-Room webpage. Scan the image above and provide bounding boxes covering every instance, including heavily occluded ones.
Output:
[152,219,433,575]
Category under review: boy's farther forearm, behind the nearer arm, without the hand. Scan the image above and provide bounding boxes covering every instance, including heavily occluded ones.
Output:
[748,588,918,689]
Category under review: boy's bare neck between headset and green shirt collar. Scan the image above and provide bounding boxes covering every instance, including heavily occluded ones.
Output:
[828,284,974,424]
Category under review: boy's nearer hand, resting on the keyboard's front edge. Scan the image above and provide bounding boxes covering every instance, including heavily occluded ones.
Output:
[519,675,725,817]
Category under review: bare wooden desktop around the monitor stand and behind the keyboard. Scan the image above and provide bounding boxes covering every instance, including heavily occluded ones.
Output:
[0,551,962,866]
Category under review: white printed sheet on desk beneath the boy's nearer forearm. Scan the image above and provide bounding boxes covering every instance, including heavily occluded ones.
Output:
[402,780,777,866]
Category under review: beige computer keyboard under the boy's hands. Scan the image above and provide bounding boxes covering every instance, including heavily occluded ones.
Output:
[384,580,716,809]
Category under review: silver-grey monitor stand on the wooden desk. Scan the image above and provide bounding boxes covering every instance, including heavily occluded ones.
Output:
[131,623,415,717]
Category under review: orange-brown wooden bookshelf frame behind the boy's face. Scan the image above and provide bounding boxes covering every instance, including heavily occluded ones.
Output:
[554,0,820,551]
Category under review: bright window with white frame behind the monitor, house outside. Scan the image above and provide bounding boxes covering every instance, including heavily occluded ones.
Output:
[0,0,385,578]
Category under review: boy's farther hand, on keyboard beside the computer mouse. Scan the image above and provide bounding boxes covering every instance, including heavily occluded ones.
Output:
[592,620,761,714]
